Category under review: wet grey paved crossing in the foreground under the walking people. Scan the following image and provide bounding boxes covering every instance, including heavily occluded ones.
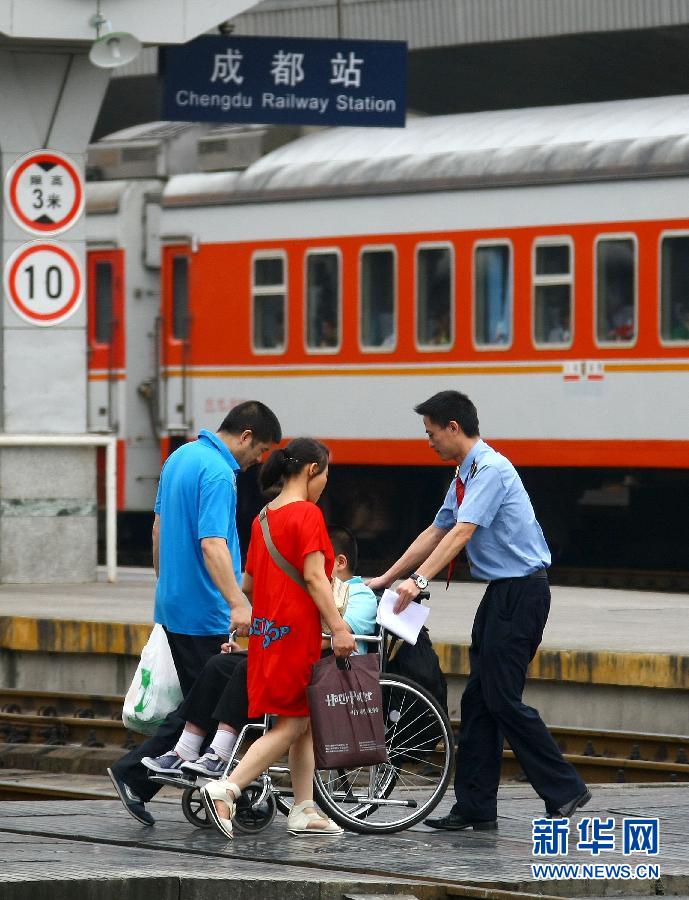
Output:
[0,785,689,900]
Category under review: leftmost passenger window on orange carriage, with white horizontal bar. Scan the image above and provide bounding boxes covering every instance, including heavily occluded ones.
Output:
[252,255,287,353]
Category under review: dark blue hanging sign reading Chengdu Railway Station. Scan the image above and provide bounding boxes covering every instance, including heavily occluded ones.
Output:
[160,35,407,128]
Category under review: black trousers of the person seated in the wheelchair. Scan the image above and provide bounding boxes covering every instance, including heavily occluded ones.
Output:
[179,653,249,737]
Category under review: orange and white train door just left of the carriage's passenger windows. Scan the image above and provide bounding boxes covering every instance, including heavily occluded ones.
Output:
[158,245,193,450]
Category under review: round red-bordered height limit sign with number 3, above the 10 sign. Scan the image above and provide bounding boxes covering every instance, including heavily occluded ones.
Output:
[5,150,84,237]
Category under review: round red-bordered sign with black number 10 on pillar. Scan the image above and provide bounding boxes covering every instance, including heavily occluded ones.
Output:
[5,241,84,325]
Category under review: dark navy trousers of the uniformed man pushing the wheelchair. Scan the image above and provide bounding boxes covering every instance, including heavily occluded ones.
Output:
[453,577,585,821]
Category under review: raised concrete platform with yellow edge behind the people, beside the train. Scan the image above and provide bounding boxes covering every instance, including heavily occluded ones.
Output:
[0,570,689,735]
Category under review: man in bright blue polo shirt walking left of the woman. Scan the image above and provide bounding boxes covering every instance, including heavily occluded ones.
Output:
[108,400,282,825]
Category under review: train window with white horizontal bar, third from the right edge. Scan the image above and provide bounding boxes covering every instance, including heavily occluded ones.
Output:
[533,240,572,346]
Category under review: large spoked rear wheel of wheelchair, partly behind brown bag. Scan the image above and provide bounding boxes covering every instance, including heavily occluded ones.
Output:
[314,673,454,834]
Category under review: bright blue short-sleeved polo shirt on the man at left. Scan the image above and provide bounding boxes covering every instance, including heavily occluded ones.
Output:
[154,428,241,635]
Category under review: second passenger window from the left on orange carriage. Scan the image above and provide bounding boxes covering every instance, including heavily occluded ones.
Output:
[306,250,340,353]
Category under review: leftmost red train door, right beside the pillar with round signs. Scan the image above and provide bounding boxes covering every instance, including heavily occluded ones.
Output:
[87,250,126,433]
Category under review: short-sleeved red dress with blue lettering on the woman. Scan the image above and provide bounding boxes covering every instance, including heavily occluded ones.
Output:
[246,500,335,718]
